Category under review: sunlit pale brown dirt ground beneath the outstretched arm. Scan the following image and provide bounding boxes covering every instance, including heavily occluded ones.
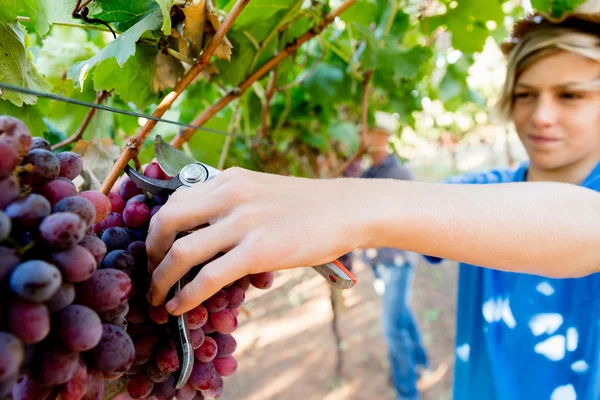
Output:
[221,261,457,400]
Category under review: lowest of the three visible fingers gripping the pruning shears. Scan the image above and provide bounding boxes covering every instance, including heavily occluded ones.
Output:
[167,246,249,315]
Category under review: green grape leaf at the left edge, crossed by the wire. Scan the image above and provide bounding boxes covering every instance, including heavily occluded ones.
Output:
[0,19,51,106]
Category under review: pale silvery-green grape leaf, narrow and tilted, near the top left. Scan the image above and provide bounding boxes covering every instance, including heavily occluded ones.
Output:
[67,10,162,87]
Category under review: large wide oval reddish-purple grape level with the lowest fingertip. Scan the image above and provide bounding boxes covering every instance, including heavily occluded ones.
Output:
[77,268,131,311]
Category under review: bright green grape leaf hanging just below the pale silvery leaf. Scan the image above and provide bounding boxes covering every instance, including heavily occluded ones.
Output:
[94,45,157,110]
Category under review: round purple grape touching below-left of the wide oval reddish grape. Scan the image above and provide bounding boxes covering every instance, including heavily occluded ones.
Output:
[58,304,102,351]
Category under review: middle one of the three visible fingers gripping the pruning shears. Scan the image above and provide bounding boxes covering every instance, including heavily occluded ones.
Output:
[148,221,238,306]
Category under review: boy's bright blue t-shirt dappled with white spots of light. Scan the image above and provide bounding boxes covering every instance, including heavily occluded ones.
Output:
[427,163,600,400]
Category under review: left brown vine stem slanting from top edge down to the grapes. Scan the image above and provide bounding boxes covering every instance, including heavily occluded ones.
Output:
[100,0,250,194]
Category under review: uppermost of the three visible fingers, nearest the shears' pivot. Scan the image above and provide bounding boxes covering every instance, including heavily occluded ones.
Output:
[146,183,222,270]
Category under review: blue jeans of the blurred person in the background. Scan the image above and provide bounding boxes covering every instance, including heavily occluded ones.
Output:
[373,263,428,400]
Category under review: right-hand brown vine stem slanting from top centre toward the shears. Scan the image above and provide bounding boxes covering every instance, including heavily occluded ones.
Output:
[171,0,356,148]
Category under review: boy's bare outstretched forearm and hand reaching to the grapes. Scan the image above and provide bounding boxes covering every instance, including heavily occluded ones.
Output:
[147,168,600,314]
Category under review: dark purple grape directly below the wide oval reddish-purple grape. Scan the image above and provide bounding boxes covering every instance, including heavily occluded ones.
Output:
[92,324,135,373]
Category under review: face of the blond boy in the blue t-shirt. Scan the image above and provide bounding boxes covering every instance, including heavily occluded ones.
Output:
[512,51,600,170]
